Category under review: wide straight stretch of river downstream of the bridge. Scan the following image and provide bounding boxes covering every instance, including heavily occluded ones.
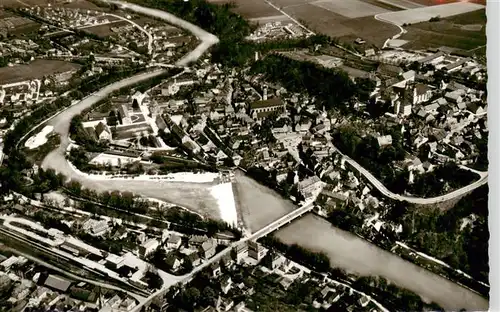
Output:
[275,214,488,311]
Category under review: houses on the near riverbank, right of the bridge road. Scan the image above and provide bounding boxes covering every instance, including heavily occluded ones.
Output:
[170,241,379,312]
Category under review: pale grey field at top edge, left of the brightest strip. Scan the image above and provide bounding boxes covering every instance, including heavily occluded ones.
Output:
[311,0,390,18]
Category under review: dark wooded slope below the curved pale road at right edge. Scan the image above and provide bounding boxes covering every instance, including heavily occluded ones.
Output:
[391,185,490,282]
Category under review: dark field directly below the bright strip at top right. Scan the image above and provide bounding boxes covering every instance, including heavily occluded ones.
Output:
[400,9,486,55]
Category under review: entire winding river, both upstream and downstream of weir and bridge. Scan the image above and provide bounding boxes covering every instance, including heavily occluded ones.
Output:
[35,1,488,311]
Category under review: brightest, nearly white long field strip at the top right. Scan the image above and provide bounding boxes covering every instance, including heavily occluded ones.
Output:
[378,2,484,26]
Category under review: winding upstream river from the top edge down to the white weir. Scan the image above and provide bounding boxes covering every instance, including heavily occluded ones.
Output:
[42,1,225,218]
